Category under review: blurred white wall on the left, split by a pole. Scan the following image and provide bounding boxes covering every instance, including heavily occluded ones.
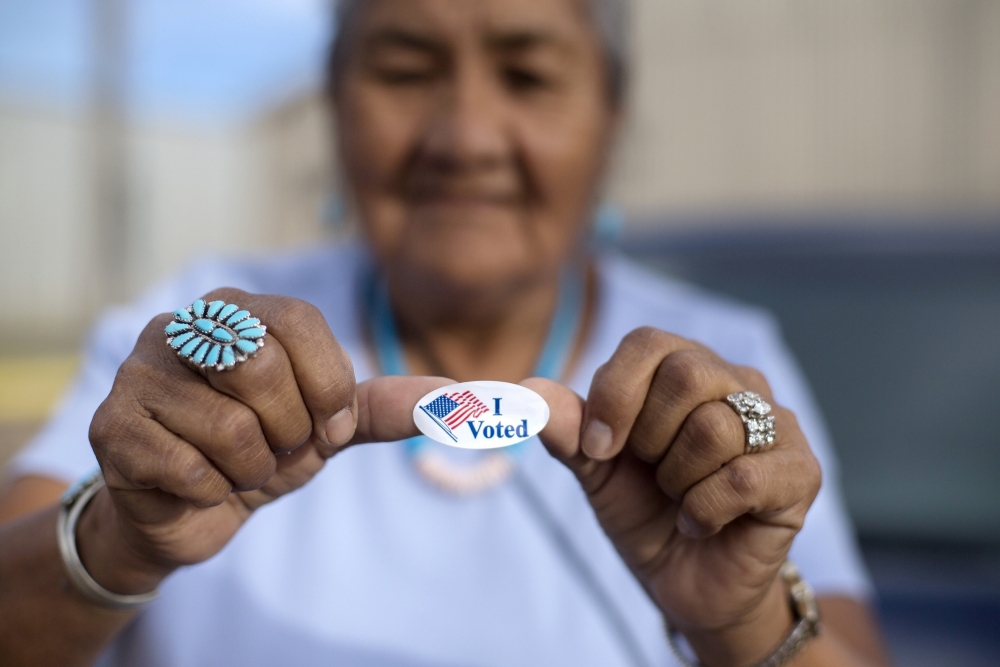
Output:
[0,107,275,352]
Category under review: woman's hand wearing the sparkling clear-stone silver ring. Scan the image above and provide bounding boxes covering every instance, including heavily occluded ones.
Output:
[524,328,820,666]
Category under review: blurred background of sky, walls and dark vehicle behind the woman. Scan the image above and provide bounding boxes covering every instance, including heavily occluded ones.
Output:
[0,0,1000,667]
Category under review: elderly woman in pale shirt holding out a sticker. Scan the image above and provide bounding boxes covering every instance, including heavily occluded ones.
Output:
[0,0,885,667]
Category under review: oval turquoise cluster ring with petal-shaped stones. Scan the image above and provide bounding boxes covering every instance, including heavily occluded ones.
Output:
[164,299,267,371]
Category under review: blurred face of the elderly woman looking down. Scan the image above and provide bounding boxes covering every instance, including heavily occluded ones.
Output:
[335,0,615,291]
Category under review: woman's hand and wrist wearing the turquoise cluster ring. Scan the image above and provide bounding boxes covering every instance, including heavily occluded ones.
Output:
[77,289,449,593]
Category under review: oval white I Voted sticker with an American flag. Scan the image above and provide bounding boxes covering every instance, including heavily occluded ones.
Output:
[413,380,549,449]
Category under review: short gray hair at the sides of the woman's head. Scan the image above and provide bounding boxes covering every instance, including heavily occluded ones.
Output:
[327,0,630,106]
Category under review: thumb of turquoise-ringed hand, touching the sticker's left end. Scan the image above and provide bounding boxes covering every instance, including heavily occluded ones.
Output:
[346,375,455,446]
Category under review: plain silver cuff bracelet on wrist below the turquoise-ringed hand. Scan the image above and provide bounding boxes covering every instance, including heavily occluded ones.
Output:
[56,469,160,609]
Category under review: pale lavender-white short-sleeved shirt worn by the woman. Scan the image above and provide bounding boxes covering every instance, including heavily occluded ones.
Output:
[10,245,871,667]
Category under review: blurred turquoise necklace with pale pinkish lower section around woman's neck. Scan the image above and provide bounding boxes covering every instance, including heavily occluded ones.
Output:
[367,269,585,495]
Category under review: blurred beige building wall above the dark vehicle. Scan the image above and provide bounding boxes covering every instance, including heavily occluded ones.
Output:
[612,0,1000,223]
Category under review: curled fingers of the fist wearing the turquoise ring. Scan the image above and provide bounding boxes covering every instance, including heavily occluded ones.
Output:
[91,289,372,522]
